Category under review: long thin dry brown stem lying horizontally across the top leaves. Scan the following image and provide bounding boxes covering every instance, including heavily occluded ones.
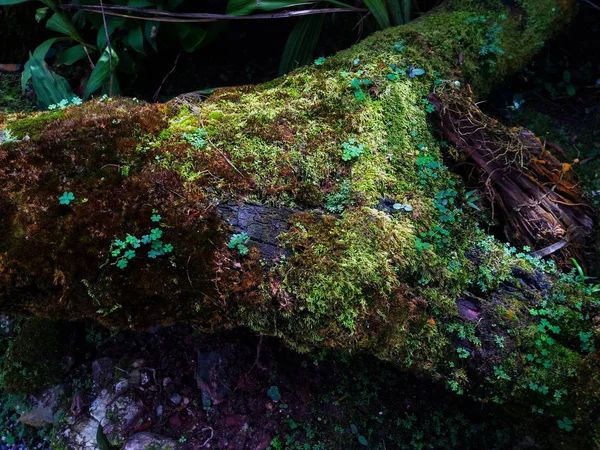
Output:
[60,4,369,23]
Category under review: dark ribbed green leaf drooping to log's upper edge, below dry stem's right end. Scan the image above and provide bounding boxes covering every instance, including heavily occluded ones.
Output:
[278,14,325,75]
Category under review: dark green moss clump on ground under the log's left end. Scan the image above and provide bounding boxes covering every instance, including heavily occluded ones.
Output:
[0,318,64,394]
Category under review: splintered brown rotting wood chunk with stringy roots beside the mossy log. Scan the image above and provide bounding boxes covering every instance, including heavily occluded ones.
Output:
[428,91,596,265]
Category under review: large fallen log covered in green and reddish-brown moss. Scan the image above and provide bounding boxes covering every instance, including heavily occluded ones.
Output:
[0,0,600,442]
